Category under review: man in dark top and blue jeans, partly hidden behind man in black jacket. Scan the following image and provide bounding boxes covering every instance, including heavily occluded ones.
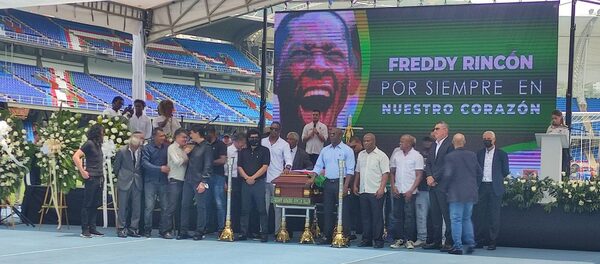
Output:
[206,126,227,235]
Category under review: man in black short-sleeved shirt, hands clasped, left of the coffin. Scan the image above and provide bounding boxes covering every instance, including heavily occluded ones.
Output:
[237,129,271,242]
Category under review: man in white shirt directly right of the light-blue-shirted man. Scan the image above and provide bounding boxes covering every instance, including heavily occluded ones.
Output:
[353,133,390,248]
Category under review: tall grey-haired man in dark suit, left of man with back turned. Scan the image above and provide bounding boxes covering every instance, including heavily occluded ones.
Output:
[423,121,454,251]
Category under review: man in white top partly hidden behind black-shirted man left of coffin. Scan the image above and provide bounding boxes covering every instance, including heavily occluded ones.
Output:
[225,133,246,230]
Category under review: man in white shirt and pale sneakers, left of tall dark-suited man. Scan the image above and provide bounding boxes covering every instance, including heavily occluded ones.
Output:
[390,135,424,249]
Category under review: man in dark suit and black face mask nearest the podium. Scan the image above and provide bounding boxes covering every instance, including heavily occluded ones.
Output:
[475,131,510,250]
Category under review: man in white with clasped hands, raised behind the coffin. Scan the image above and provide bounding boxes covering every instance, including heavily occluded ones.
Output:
[302,109,328,164]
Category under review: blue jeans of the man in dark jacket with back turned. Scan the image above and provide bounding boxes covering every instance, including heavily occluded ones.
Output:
[449,202,475,249]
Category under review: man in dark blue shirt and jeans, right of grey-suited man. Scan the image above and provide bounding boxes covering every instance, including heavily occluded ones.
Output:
[142,128,170,237]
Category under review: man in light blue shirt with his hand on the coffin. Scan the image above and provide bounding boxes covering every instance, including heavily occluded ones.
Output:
[313,128,355,245]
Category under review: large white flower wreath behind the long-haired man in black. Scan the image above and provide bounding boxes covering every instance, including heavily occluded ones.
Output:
[36,110,82,193]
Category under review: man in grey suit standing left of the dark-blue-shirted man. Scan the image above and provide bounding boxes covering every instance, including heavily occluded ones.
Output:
[114,131,144,238]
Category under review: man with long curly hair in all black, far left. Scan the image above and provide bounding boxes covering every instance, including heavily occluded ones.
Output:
[73,124,104,238]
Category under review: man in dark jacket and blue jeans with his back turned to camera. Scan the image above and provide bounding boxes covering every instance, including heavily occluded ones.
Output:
[441,133,482,255]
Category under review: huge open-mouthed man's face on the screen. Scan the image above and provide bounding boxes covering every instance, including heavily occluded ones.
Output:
[279,13,351,126]
